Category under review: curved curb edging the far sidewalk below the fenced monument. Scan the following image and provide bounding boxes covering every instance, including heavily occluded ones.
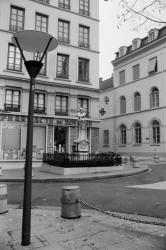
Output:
[0,166,149,183]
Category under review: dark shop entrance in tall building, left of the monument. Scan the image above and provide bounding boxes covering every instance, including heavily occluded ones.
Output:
[54,126,67,152]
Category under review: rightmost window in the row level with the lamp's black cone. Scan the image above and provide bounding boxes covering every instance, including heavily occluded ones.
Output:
[78,58,89,82]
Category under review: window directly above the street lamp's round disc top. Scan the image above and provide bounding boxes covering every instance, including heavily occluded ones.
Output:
[35,13,48,32]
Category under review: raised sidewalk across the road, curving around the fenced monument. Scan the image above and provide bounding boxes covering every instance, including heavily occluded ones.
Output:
[0,165,148,182]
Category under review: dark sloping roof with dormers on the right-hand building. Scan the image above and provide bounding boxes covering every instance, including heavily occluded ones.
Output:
[114,26,166,61]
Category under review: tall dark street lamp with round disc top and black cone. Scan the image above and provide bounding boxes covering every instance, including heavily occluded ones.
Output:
[12,30,58,246]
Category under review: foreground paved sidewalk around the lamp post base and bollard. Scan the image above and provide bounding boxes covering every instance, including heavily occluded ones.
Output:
[0,206,166,250]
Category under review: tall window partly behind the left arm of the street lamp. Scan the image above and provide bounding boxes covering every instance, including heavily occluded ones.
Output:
[7,43,22,71]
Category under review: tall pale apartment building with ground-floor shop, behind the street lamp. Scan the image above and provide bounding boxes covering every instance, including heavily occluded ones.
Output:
[0,0,99,167]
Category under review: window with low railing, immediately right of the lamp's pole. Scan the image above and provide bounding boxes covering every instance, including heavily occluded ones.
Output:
[34,93,45,114]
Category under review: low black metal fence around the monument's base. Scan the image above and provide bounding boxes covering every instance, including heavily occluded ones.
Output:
[43,152,122,168]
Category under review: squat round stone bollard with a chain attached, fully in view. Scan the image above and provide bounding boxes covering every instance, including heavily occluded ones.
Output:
[61,186,81,219]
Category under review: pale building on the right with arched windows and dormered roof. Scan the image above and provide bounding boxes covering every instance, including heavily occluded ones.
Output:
[100,27,166,155]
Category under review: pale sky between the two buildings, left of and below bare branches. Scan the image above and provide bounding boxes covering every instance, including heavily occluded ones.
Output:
[99,0,147,80]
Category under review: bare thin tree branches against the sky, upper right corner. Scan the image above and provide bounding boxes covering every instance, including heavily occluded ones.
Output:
[108,0,166,30]
